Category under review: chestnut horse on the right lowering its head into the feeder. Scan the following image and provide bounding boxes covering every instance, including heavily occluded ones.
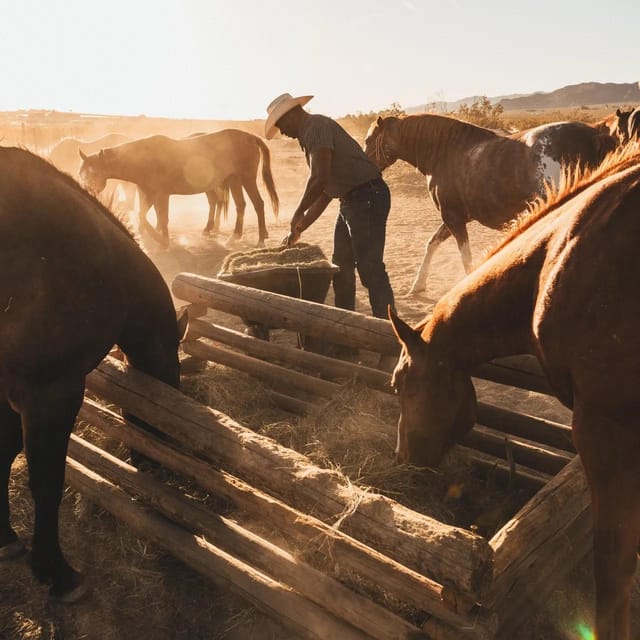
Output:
[390,148,640,640]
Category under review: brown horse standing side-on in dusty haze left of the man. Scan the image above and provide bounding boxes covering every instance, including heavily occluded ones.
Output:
[80,129,278,245]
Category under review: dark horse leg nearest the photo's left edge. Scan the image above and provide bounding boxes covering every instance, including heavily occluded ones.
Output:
[0,402,24,560]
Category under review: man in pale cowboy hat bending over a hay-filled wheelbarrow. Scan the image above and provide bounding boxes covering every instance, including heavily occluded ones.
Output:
[265,93,394,318]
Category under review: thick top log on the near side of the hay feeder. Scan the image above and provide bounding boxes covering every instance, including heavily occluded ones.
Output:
[87,358,492,594]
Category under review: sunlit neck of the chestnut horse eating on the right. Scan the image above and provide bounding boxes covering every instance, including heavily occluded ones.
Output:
[423,243,545,370]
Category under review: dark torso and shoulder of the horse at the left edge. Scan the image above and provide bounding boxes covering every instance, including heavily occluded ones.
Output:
[0,148,172,388]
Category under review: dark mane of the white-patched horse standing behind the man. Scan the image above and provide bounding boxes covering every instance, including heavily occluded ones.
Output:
[398,113,500,168]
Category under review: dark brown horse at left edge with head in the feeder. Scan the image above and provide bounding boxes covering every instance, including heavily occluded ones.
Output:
[0,148,186,602]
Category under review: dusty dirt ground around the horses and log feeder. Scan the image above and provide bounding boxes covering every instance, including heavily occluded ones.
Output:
[0,126,636,640]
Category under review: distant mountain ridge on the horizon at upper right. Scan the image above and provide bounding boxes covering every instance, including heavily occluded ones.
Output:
[405,82,640,113]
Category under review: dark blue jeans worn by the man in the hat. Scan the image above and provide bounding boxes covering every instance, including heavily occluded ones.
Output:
[332,178,394,318]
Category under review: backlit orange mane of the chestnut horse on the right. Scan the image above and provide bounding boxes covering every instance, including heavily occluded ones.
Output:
[485,144,640,261]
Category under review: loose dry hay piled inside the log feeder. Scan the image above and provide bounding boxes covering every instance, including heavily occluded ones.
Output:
[183,365,530,536]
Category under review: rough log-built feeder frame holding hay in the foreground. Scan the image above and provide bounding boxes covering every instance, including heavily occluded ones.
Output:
[62,274,591,640]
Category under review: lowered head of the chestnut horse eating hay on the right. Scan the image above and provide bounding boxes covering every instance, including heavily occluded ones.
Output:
[389,310,477,467]
